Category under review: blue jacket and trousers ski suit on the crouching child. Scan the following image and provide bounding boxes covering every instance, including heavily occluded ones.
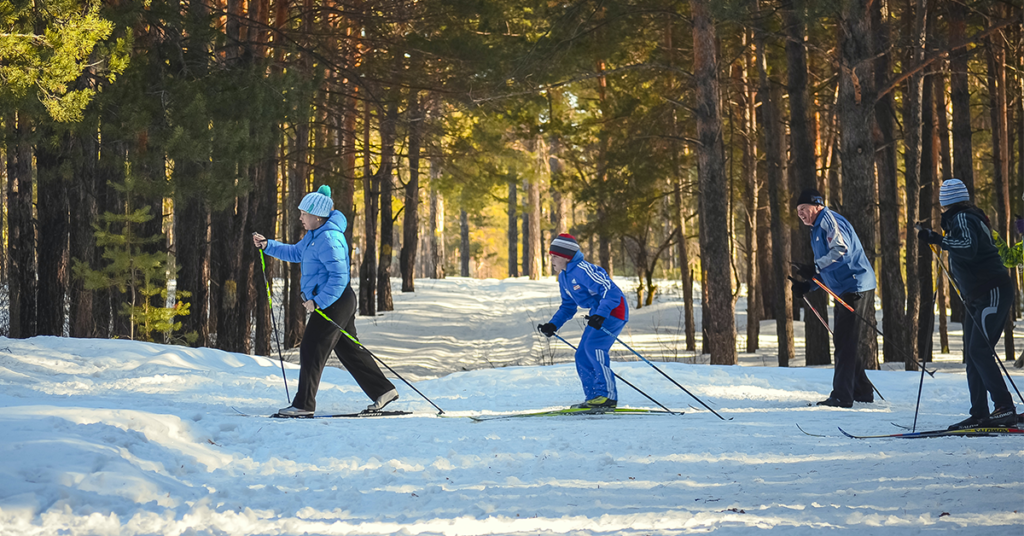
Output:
[551,251,630,400]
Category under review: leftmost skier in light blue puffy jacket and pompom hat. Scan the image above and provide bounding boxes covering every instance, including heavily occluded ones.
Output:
[253,185,398,417]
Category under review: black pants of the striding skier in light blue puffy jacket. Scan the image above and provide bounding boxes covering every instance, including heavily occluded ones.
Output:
[292,286,394,411]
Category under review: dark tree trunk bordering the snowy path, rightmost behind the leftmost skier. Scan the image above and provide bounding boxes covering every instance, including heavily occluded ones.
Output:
[398,91,423,292]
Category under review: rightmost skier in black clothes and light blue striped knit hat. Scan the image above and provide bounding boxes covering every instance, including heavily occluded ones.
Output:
[918,178,1017,429]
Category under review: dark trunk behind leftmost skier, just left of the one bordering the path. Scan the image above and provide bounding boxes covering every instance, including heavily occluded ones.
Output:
[377,101,398,311]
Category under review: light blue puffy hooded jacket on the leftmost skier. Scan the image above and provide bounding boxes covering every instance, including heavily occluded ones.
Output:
[263,210,350,308]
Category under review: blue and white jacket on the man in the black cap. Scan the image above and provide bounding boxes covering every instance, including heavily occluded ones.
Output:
[811,207,876,295]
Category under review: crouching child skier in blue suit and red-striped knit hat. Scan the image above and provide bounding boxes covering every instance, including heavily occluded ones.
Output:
[537,234,630,409]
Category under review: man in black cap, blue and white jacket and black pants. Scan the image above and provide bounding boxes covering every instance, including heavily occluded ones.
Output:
[791,189,874,408]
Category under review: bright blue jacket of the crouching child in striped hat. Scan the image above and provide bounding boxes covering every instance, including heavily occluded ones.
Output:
[551,251,630,328]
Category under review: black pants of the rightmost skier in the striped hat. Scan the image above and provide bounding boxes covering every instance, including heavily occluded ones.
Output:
[964,283,1014,418]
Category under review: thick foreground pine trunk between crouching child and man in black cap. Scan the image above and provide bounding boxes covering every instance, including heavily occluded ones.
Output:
[690,0,736,365]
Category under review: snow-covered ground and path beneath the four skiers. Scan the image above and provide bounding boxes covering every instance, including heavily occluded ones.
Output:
[0,279,1024,535]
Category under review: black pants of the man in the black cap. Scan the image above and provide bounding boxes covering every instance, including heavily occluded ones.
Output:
[831,289,874,406]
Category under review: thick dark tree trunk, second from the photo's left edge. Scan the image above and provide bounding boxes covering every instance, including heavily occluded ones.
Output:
[36,127,71,337]
